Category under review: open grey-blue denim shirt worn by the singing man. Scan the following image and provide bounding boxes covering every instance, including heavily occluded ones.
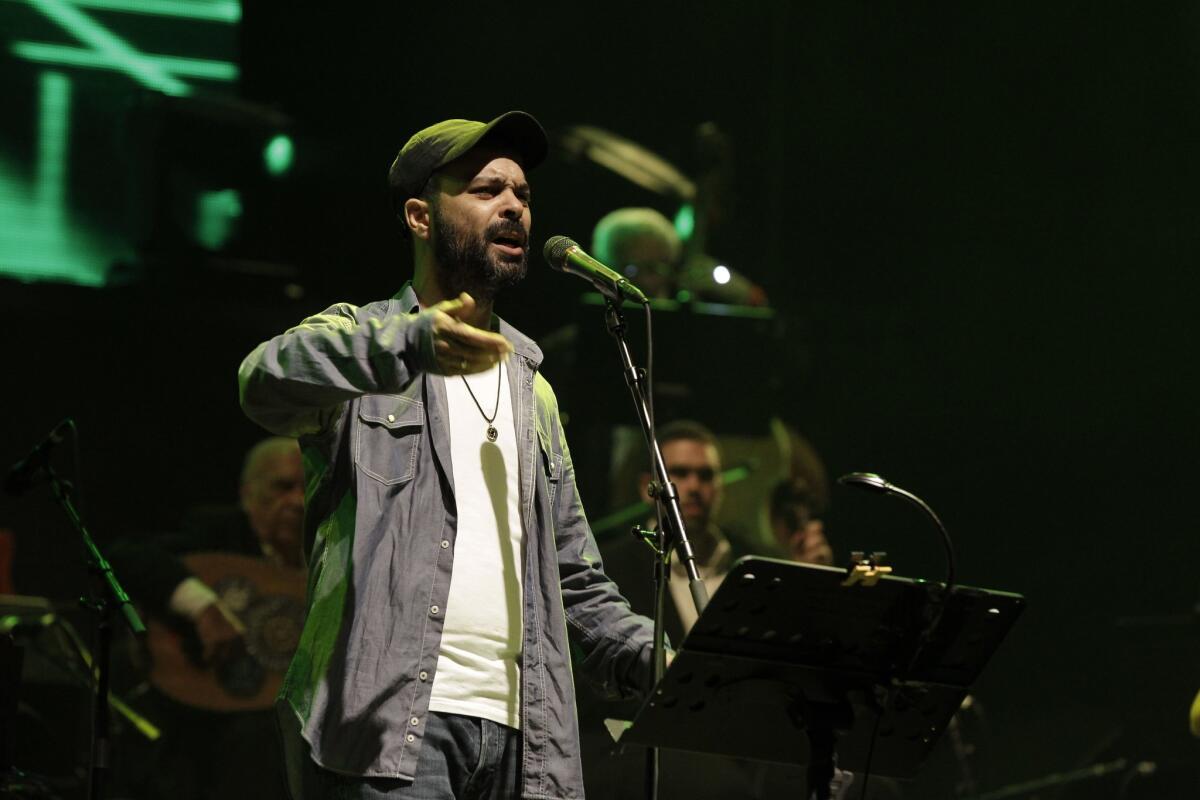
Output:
[239,285,652,800]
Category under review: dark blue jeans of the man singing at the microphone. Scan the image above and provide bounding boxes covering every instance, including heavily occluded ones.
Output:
[318,711,521,800]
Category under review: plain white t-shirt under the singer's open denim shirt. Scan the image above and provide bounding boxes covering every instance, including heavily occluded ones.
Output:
[430,363,524,728]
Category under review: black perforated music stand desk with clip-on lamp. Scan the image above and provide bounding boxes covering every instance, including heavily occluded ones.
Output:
[619,558,1025,796]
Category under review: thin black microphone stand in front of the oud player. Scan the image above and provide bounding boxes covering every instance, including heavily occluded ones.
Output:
[44,467,146,800]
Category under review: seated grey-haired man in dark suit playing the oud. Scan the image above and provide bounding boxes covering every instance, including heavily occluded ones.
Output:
[109,437,304,800]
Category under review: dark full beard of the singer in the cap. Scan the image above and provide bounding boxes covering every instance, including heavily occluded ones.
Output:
[430,205,529,301]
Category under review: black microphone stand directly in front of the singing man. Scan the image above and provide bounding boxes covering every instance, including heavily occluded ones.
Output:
[605,299,708,800]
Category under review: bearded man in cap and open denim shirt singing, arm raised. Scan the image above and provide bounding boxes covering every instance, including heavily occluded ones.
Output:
[239,112,652,800]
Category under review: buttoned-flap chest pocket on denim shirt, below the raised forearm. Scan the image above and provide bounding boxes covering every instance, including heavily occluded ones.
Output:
[354,395,425,486]
